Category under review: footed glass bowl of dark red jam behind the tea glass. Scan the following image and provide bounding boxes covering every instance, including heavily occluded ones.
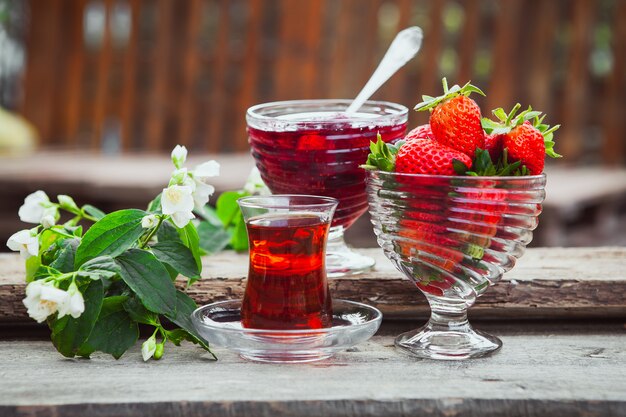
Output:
[246,100,408,277]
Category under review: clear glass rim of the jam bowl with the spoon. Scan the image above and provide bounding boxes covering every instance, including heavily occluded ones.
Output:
[246,99,409,125]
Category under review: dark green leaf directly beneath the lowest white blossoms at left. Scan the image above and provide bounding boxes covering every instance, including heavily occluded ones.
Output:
[50,281,104,358]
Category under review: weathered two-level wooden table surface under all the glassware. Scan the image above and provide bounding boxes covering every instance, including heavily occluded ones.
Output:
[0,247,626,417]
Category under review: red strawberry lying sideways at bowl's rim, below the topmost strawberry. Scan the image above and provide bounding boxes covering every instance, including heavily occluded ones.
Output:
[395,138,472,175]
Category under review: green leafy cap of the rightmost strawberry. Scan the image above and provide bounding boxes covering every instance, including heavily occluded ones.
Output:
[481,103,562,158]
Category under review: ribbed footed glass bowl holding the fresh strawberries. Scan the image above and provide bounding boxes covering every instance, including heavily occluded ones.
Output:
[367,171,546,359]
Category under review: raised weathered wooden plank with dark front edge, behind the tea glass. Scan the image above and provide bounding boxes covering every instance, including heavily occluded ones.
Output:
[0,248,626,322]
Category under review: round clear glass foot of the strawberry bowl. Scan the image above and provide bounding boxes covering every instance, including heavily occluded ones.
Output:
[395,324,502,360]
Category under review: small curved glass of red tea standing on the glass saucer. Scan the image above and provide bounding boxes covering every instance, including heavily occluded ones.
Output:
[240,196,337,330]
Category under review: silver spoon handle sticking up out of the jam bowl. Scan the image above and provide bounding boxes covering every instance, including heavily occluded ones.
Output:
[346,26,423,114]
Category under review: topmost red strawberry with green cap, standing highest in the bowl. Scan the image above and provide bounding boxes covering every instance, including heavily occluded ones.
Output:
[415,78,485,159]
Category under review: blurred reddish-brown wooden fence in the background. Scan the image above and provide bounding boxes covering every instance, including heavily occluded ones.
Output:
[21,0,626,164]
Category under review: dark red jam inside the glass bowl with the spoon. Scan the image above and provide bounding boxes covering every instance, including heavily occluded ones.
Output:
[248,105,406,228]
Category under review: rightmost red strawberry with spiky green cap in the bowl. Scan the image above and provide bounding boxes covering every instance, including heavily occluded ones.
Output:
[483,103,561,175]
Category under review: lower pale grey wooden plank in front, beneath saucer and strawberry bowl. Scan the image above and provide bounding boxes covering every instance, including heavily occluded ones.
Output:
[0,323,626,417]
